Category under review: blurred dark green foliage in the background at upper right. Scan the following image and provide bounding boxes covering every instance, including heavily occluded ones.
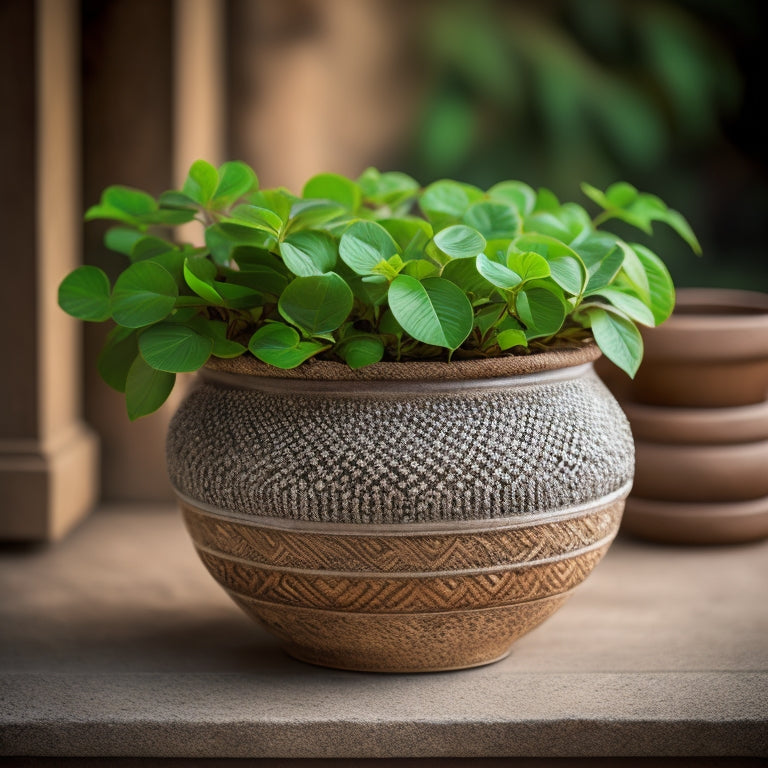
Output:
[401,0,768,290]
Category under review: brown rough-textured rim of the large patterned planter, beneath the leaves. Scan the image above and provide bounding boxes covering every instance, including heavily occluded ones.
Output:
[201,343,601,382]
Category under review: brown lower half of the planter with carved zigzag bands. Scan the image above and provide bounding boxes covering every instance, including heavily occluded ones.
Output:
[181,500,624,672]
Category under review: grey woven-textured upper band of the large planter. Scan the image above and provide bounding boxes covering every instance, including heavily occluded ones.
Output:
[168,364,634,524]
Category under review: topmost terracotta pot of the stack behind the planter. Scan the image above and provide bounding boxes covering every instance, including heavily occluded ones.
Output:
[632,288,768,408]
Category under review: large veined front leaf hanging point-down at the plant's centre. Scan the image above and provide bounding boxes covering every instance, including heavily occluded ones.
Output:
[389,275,473,350]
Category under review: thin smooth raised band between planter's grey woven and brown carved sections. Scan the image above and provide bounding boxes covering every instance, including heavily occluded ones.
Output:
[173,480,633,536]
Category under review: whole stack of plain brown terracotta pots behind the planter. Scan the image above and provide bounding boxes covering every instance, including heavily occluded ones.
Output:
[601,289,768,544]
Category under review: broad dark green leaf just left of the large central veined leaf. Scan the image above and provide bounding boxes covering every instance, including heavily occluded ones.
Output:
[277,272,354,336]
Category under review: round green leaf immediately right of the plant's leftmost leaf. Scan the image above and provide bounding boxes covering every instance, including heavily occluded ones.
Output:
[112,261,179,328]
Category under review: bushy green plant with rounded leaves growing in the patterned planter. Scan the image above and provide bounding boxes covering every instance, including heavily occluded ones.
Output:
[59,160,700,419]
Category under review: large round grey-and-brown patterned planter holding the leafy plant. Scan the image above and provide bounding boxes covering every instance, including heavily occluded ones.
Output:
[168,347,634,672]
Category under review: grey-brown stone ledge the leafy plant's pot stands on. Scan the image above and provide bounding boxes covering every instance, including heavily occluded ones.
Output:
[0,507,768,765]
